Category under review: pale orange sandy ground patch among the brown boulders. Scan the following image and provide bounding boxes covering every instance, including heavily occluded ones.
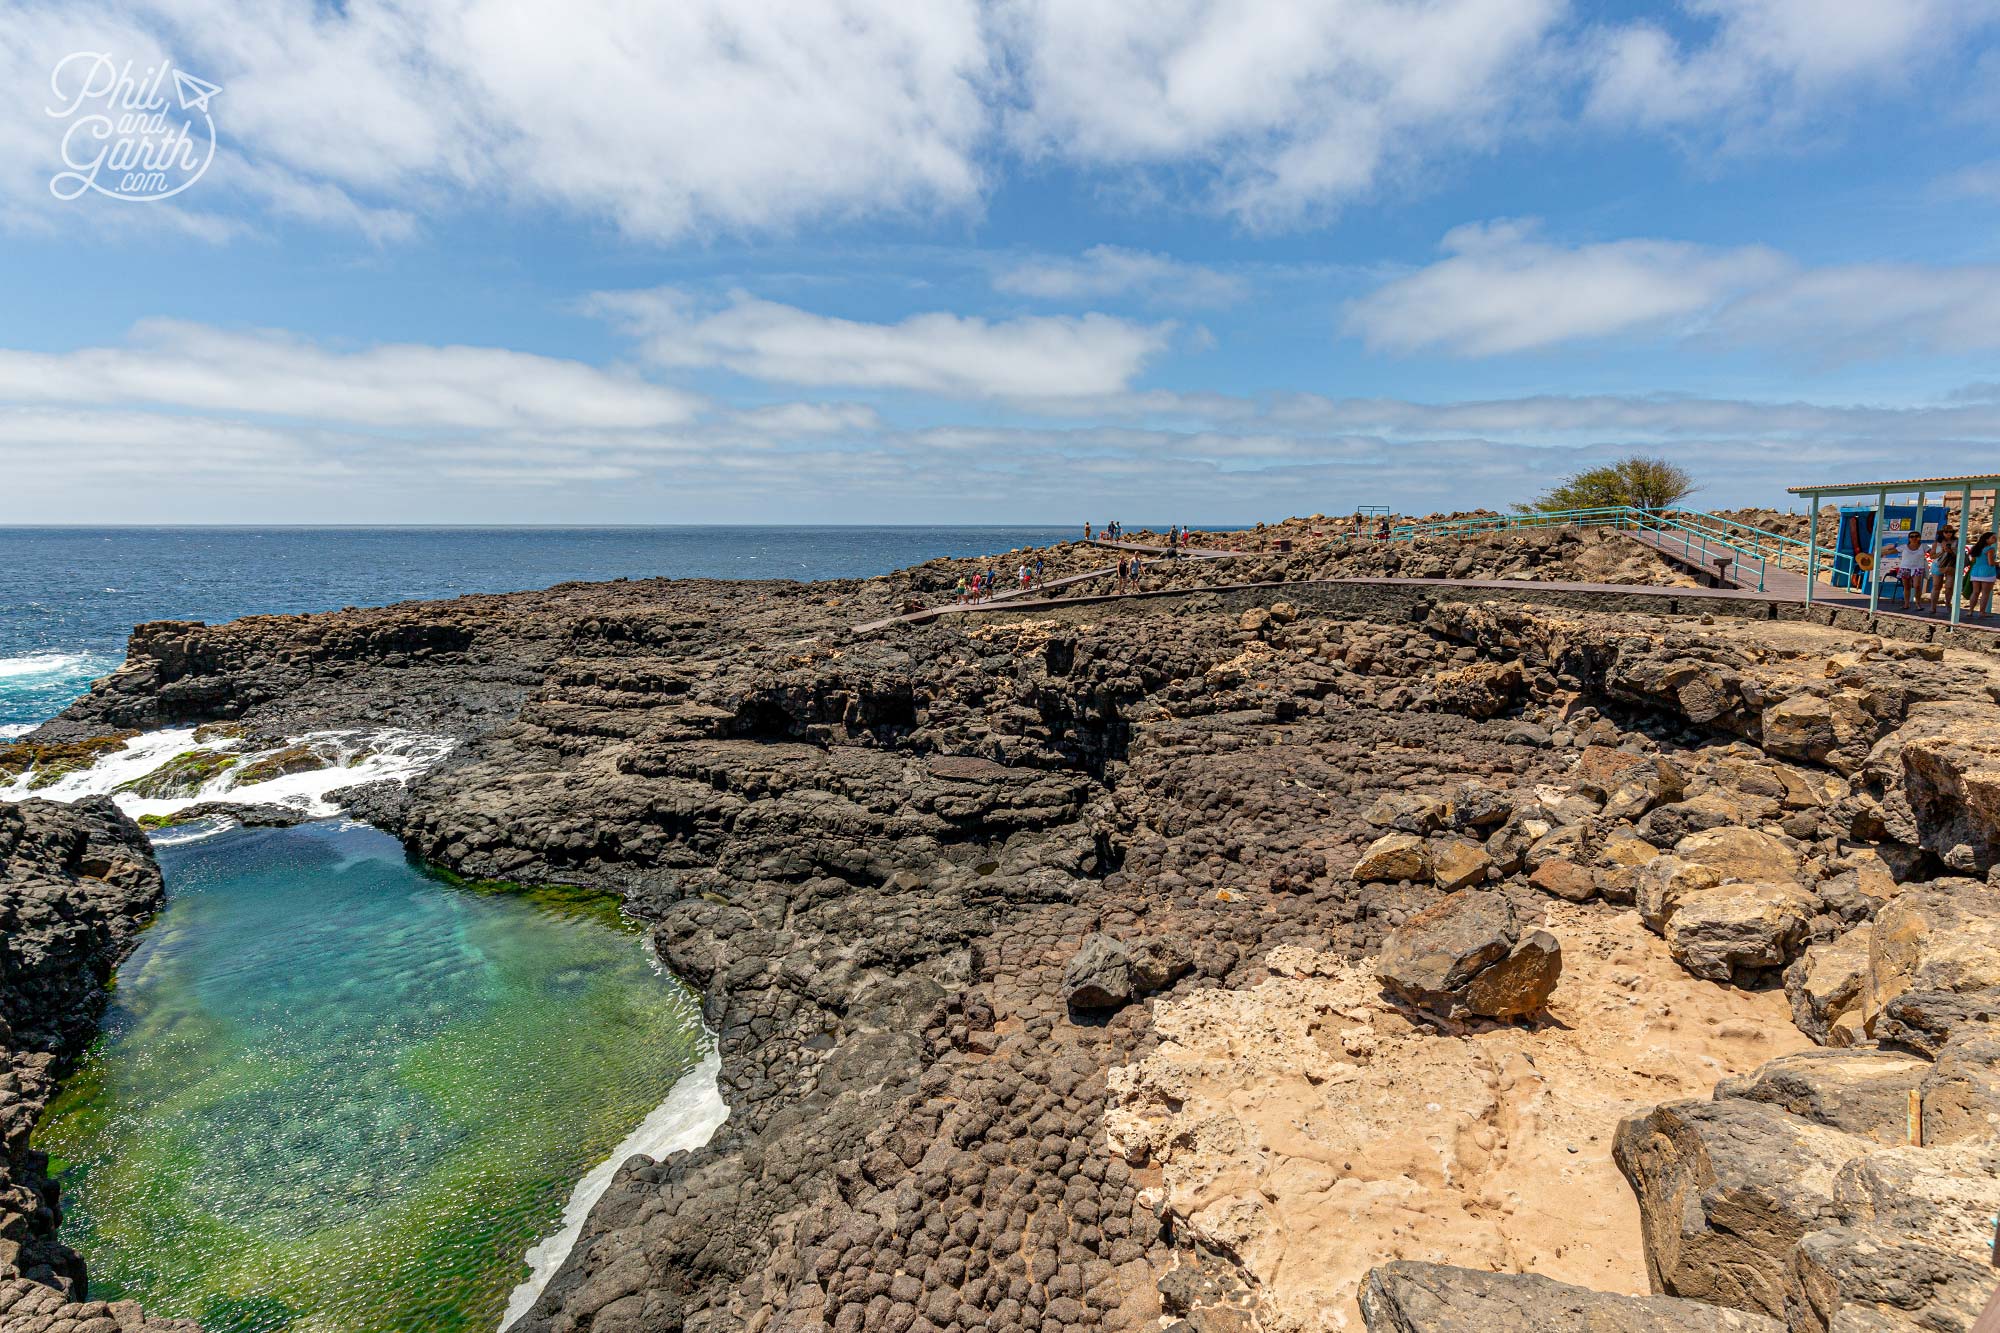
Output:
[1108,903,1806,1333]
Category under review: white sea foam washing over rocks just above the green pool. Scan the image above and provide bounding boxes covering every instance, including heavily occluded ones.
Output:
[0,727,452,833]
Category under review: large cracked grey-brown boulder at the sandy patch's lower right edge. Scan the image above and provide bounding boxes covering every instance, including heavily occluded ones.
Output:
[1612,1097,1872,1319]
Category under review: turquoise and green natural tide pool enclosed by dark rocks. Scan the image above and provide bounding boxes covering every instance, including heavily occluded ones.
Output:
[36,825,706,1333]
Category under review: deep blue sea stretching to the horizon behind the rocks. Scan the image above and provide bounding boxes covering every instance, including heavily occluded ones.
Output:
[0,526,1074,739]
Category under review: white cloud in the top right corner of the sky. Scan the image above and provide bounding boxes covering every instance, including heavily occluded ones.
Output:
[1588,0,1996,138]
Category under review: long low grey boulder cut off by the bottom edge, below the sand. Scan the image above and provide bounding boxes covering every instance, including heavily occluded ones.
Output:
[1360,1259,1784,1333]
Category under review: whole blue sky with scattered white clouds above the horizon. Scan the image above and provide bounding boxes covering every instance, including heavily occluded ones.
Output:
[0,0,2000,522]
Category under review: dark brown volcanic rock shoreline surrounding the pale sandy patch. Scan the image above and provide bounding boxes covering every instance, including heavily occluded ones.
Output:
[11,532,2000,1333]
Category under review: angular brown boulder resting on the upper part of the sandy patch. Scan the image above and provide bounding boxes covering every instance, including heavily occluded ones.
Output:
[1376,889,1562,1019]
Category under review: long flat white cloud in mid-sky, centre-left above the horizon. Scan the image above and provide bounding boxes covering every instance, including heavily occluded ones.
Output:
[590,288,1174,398]
